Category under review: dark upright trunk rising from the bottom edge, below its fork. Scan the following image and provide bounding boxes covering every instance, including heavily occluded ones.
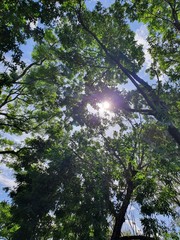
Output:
[111,180,133,240]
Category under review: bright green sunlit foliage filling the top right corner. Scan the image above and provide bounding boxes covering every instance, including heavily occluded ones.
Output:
[125,0,180,81]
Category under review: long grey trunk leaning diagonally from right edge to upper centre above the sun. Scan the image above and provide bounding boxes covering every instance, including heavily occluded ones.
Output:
[78,1,180,144]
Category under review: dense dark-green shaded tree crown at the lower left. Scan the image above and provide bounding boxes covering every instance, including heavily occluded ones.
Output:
[6,125,107,239]
